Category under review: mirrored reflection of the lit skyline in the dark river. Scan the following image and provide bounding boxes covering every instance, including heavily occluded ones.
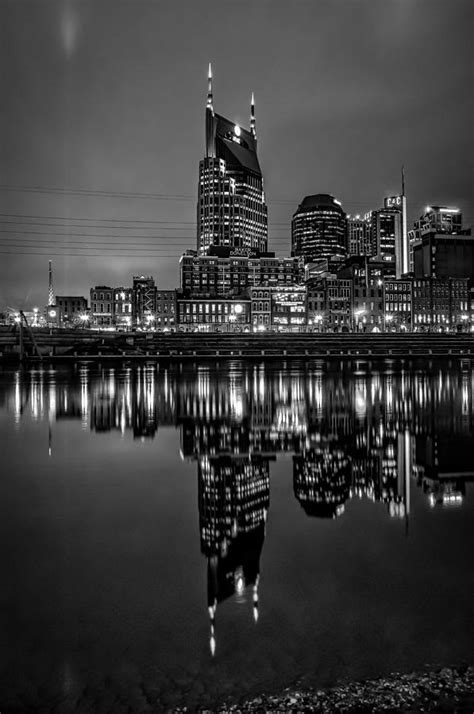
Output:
[5,363,474,653]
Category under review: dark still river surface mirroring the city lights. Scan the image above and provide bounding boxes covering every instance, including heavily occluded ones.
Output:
[0,362,474,712]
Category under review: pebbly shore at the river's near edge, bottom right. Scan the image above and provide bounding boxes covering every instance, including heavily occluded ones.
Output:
[189,666,474,714]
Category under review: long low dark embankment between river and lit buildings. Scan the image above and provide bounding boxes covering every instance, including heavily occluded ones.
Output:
[0,327,474,360]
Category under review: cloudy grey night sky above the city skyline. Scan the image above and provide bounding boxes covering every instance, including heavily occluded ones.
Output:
[0,0,474,309]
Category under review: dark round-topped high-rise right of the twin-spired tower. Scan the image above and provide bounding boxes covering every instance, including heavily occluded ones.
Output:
[291,193,347,264]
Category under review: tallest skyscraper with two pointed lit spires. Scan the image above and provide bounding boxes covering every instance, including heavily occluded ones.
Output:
[197,65,268,254]
